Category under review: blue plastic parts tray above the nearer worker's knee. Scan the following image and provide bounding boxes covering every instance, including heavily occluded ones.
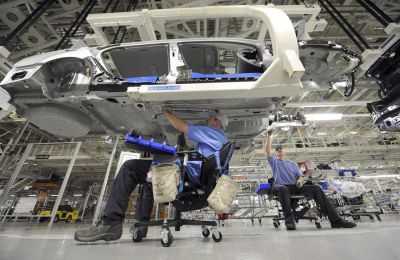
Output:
[125,134,176,155]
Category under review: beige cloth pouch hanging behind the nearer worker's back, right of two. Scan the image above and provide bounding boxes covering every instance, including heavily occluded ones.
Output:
[207,175,238,213]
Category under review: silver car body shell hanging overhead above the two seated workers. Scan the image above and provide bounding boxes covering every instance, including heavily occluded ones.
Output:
[1,38,360,146]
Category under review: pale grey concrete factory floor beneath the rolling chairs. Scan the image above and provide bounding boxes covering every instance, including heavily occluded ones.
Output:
[0,218,400,260]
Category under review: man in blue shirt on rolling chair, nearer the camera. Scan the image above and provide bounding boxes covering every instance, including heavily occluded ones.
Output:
[74,108,228,242]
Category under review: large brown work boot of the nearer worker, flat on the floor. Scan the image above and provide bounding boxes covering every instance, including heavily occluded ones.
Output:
[74,216,122,242]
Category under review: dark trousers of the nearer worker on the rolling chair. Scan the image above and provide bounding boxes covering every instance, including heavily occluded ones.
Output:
[103,160,154,221]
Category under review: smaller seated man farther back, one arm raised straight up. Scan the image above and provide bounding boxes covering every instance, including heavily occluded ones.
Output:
[265,131,356,230]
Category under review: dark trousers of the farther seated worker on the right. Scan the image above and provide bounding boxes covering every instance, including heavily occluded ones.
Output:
[273,185,342,224]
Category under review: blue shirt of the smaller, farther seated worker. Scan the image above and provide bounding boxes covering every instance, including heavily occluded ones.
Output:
[268,155,303,185]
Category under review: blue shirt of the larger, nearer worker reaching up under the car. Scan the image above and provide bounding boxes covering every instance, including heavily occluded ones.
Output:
[178,125,228,185]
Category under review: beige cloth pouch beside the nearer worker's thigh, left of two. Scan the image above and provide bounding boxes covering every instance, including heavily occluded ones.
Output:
[151,164,179,203]
